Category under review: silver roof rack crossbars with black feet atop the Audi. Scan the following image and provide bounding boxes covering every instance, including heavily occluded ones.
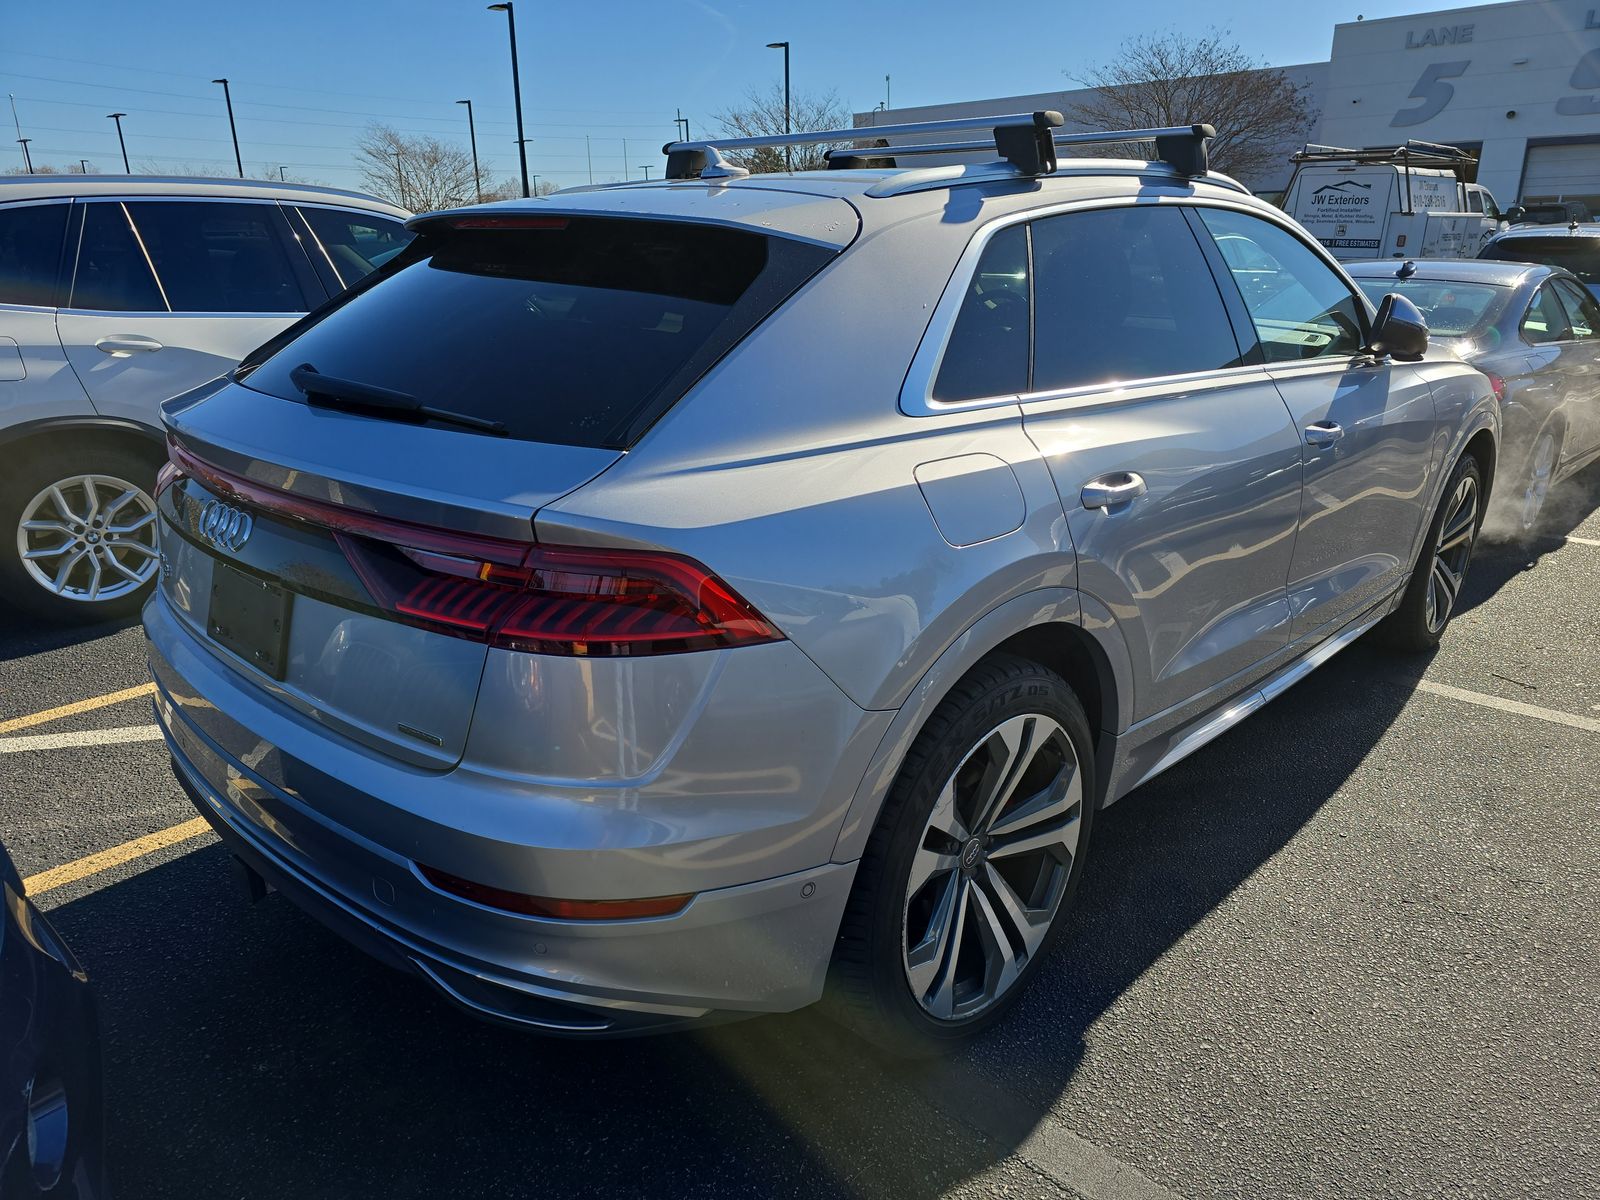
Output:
[662,110,1216,179]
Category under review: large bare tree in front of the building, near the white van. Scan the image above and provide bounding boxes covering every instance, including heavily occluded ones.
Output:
[1070,29,1315,185]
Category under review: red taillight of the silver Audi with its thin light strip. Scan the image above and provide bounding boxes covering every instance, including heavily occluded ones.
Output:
[173,443,782,658]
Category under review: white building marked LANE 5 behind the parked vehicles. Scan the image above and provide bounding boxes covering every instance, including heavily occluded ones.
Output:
[856,0,1600,213]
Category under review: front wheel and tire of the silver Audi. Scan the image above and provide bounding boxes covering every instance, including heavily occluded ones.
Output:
[1382,454,1483,654]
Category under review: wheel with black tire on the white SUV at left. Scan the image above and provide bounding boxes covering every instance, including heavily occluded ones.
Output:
[0,442,160,624]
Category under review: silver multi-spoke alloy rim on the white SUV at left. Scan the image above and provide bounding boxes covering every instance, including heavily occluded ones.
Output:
[16,475,160,603]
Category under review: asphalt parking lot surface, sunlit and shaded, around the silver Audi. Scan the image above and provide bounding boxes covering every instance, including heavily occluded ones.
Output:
[0,470,1600,1200]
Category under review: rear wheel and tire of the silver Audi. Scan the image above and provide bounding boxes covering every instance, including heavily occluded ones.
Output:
[827,654,1098,1058]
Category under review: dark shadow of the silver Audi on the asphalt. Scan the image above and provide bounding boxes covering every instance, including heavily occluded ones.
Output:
[53,643,1426,1200]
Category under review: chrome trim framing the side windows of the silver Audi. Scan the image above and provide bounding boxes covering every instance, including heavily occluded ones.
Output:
[899,186,1370,416]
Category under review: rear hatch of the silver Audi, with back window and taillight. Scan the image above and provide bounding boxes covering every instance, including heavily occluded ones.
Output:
[160,194,856,768]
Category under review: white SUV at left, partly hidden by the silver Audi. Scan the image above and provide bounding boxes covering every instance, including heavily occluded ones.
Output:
[0,174,411,621]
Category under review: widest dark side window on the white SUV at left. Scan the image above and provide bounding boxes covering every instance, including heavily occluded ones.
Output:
[126,200,310,312]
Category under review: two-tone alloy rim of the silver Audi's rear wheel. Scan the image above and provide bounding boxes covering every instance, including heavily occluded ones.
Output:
[901,714,1083,1021]
